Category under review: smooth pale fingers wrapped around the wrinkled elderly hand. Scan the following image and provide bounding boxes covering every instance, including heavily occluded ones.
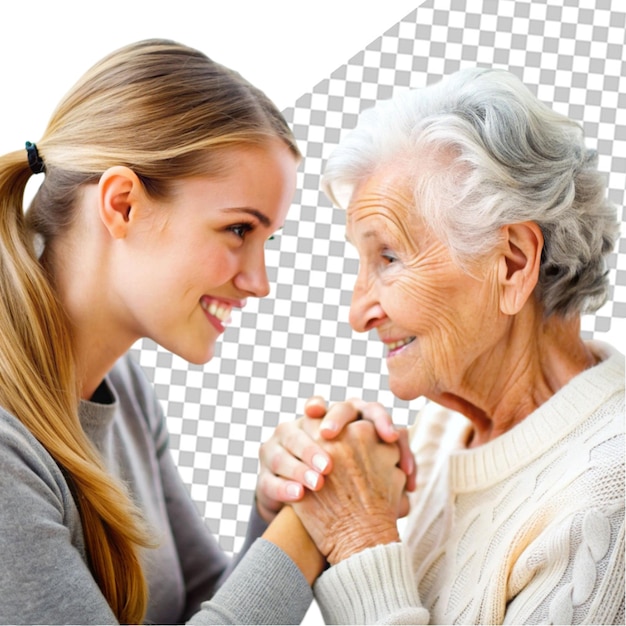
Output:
[256,396,415,522]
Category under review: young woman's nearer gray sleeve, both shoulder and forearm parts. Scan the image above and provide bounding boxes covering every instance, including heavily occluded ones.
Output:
[0,410,312,624]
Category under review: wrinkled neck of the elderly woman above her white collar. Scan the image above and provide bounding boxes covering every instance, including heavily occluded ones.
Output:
[432,305,597,447]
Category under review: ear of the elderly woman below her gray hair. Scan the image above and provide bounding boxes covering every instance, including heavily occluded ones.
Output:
[498,222,543,315]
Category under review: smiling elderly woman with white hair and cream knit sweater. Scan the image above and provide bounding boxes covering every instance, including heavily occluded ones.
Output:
[266,69,624,624]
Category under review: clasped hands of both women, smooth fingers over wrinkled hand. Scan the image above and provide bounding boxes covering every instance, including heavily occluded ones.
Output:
[257,398,415,563]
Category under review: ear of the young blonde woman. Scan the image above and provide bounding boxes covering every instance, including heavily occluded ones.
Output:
[98,165,144,239]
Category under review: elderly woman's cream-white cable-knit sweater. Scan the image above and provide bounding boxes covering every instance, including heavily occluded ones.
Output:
[315,344,625,624]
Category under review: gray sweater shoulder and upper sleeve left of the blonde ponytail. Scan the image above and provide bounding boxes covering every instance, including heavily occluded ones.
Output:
[0,410,115,624]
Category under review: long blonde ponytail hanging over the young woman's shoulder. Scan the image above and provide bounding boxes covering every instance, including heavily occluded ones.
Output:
[0,151,148,623]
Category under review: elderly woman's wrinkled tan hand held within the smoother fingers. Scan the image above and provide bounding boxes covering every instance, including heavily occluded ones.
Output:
[292,420,408,565]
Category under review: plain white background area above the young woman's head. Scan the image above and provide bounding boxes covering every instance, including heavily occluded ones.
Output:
[0,0,422,143]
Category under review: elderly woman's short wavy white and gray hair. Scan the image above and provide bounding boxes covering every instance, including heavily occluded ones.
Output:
[323,68,619,317]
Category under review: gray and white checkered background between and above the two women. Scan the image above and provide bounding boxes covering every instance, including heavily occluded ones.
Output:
[128,0,626,552]
